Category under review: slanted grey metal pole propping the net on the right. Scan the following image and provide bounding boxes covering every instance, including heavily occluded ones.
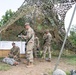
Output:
[54,3,76,71]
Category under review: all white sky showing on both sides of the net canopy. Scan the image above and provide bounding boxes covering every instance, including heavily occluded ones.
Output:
[0,0,76,30]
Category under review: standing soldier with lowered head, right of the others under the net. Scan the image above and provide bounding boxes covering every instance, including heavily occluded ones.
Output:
[43,30,52,61]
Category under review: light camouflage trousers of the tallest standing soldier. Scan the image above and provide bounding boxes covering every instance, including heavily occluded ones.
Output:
[26,43,34,63]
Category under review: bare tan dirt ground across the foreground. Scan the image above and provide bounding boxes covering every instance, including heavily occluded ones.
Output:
[0,57,76,75]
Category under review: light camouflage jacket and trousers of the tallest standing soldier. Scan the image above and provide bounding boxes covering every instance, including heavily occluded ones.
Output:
[24,27,34,63]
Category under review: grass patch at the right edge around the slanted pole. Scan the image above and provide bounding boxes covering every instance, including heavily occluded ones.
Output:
[52,51,76,65]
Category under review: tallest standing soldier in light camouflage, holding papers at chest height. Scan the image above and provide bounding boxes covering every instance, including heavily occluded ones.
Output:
[22,23,34,67]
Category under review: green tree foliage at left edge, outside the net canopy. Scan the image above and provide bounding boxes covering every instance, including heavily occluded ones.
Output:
[0,9,14,26]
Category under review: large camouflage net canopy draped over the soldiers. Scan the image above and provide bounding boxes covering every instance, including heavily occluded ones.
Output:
[0,0,75,49]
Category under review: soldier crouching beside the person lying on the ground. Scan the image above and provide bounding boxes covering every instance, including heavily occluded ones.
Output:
[8,43,20,61]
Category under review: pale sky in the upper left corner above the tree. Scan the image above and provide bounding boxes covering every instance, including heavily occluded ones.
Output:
[0,0,24,19]
